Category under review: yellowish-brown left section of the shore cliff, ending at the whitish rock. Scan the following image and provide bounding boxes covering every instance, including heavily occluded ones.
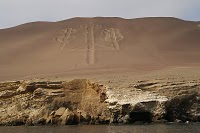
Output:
[0,80,108,125]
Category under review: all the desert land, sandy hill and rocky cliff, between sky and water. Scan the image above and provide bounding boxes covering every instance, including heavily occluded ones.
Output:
[0,17,200,125]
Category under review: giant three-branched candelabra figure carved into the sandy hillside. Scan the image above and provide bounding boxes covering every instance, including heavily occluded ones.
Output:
[56,23,124,64]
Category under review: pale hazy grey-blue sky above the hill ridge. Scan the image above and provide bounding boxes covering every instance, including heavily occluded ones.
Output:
[0,0,200,29]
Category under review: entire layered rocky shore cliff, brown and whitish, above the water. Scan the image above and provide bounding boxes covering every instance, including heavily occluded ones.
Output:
[0,79,200,125]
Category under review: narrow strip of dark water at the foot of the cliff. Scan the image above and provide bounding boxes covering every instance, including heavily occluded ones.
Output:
[0,124,200,133]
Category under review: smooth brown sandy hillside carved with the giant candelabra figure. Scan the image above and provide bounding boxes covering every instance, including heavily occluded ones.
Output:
[0,17,200,80]
